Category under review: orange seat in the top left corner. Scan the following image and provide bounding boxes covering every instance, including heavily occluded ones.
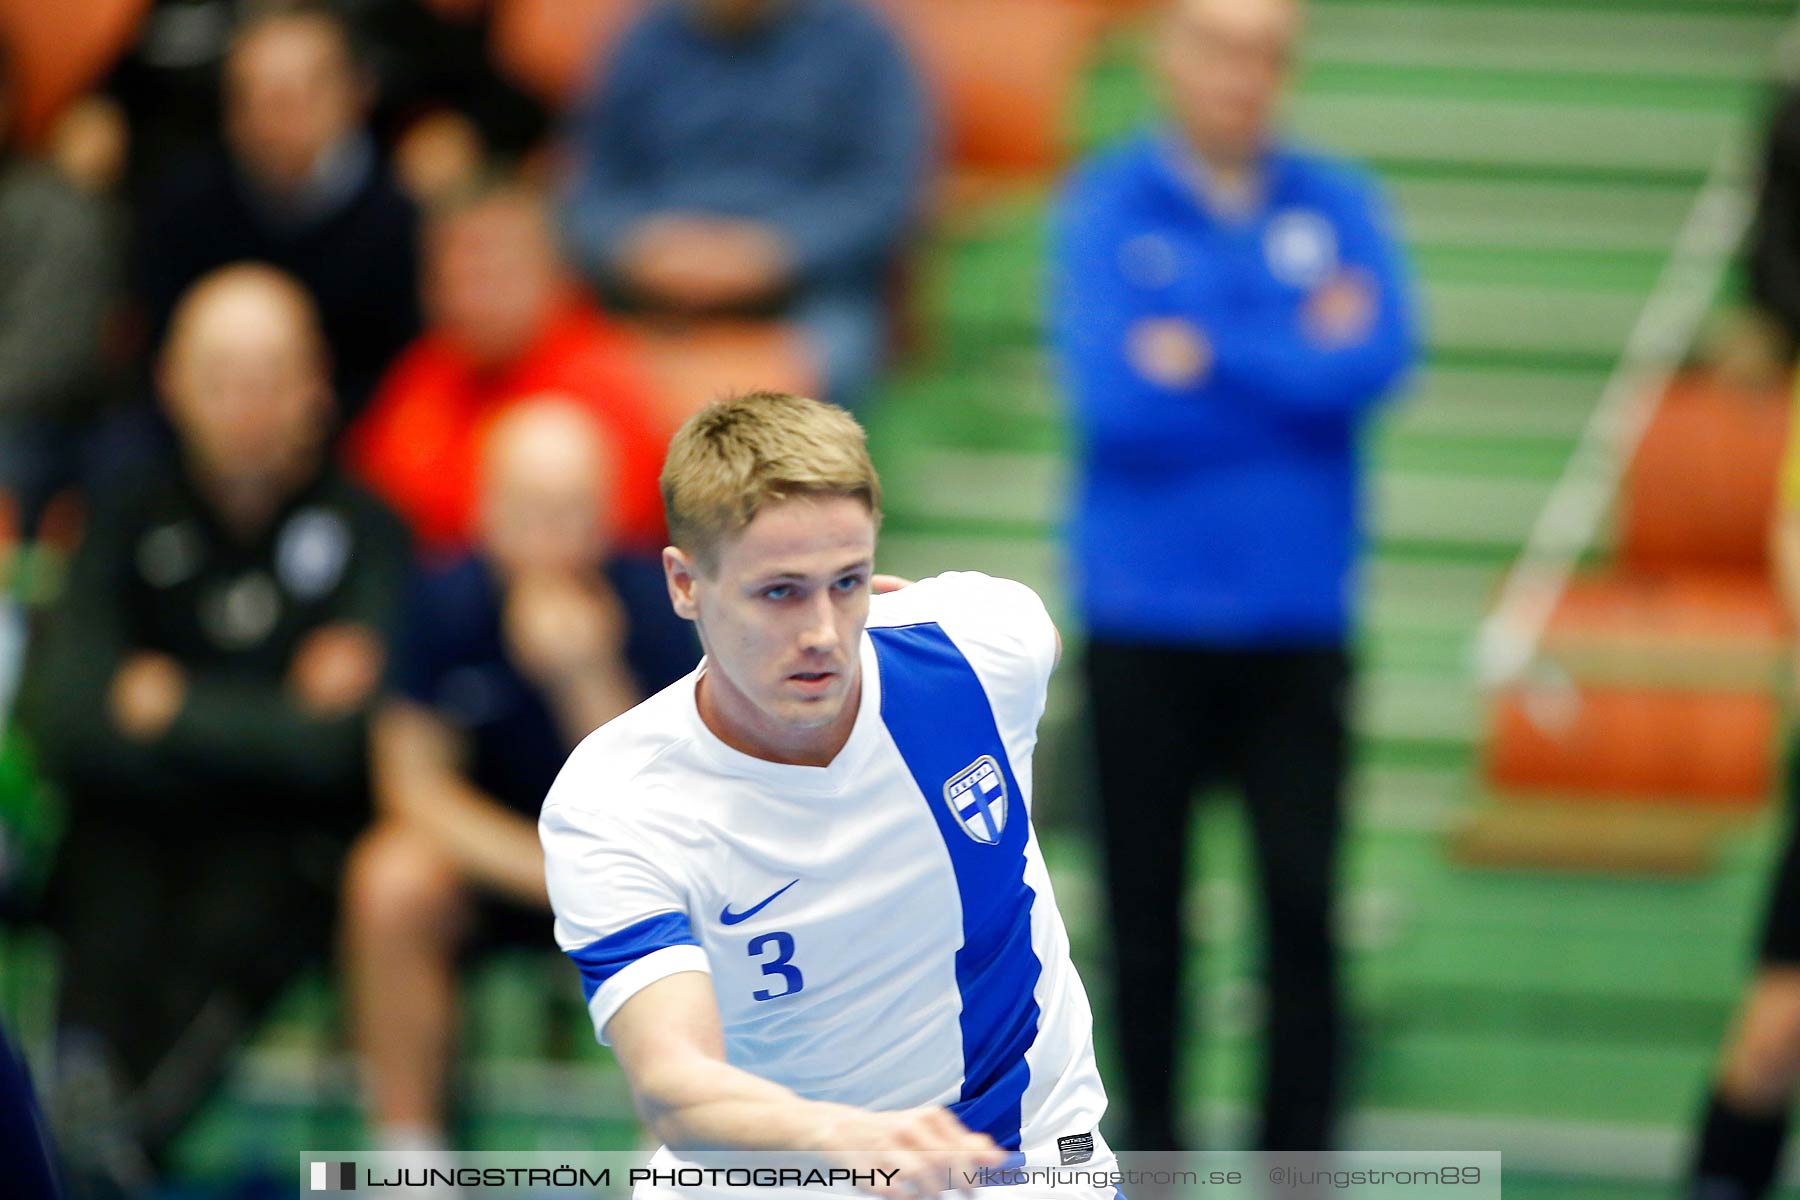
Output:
[0,0,149,146]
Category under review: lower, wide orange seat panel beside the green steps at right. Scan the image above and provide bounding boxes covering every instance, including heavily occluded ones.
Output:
[1487,685,1780,808]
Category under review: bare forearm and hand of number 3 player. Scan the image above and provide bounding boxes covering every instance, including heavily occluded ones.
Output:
[605,972,1004,1195]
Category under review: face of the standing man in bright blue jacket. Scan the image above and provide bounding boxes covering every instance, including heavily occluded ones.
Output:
[1157,0,1300,160]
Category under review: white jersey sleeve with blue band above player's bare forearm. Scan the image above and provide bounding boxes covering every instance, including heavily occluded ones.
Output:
[538,757,711,1045]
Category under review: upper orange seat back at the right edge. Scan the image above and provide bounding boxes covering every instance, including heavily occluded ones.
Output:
[1618,374,1791,572]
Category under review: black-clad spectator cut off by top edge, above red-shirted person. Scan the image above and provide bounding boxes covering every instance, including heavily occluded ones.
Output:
[351,0,551,196]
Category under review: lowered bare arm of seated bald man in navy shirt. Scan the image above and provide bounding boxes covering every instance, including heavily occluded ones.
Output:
[371,700,549,905]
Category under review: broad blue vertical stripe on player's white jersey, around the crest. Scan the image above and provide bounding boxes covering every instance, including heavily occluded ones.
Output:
[869,624,1042,1150]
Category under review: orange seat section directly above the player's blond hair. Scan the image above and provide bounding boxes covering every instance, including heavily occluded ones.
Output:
[630,320,819,430]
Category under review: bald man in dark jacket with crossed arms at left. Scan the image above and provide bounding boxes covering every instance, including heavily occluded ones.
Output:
[31,264,407,1186]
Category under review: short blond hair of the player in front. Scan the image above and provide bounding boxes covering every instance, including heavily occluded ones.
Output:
[661,392,882,570]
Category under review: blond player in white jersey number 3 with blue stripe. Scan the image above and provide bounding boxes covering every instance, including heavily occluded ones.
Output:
[540,394,1116,1198]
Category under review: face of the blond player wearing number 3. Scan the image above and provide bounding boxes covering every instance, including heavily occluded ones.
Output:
[671,497,875,757]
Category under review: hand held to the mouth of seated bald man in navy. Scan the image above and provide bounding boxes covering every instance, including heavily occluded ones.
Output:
[500,574,625,689]
